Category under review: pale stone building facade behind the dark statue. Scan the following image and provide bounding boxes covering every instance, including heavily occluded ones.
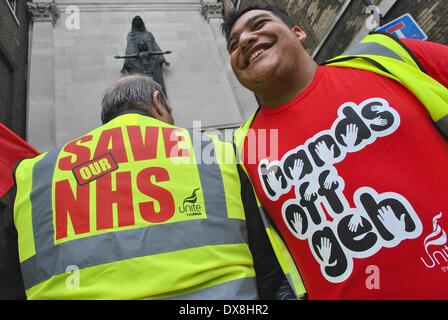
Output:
[28,0,257,150]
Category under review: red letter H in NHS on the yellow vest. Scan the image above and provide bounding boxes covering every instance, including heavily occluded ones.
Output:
[96,171,135,230]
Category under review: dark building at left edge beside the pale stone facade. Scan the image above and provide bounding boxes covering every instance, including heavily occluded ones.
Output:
[0,0,29,138]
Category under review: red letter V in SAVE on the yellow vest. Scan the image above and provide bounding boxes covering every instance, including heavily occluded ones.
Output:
[127,126,159,161]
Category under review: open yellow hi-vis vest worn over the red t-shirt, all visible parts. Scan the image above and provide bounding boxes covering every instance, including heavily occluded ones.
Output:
[234,33,448,297]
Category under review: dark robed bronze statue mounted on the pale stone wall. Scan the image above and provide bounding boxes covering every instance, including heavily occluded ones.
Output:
[115,16,171,95]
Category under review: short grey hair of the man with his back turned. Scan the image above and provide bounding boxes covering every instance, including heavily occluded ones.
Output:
[101,74,171,124]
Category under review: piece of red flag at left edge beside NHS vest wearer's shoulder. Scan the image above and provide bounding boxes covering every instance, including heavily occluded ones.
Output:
[0,123,40,197]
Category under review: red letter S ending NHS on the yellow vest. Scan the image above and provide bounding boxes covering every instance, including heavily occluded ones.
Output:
[137,167,175,223]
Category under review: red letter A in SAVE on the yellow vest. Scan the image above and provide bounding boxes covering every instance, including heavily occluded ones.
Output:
[94,127,128,163]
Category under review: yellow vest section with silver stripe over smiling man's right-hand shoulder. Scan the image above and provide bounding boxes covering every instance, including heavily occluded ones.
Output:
[324,32,448,139]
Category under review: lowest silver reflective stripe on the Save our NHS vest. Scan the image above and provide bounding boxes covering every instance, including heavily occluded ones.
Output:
[164,278,258,300]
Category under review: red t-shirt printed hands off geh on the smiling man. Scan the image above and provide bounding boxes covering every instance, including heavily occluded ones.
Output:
[244,41,448,299]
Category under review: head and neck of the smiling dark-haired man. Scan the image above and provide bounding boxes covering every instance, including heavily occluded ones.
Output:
[227,9,317,106]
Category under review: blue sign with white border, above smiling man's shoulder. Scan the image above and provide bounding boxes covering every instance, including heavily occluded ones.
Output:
[376,13,428,40]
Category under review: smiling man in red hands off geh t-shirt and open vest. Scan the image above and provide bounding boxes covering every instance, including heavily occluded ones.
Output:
[223,5,448,299]
